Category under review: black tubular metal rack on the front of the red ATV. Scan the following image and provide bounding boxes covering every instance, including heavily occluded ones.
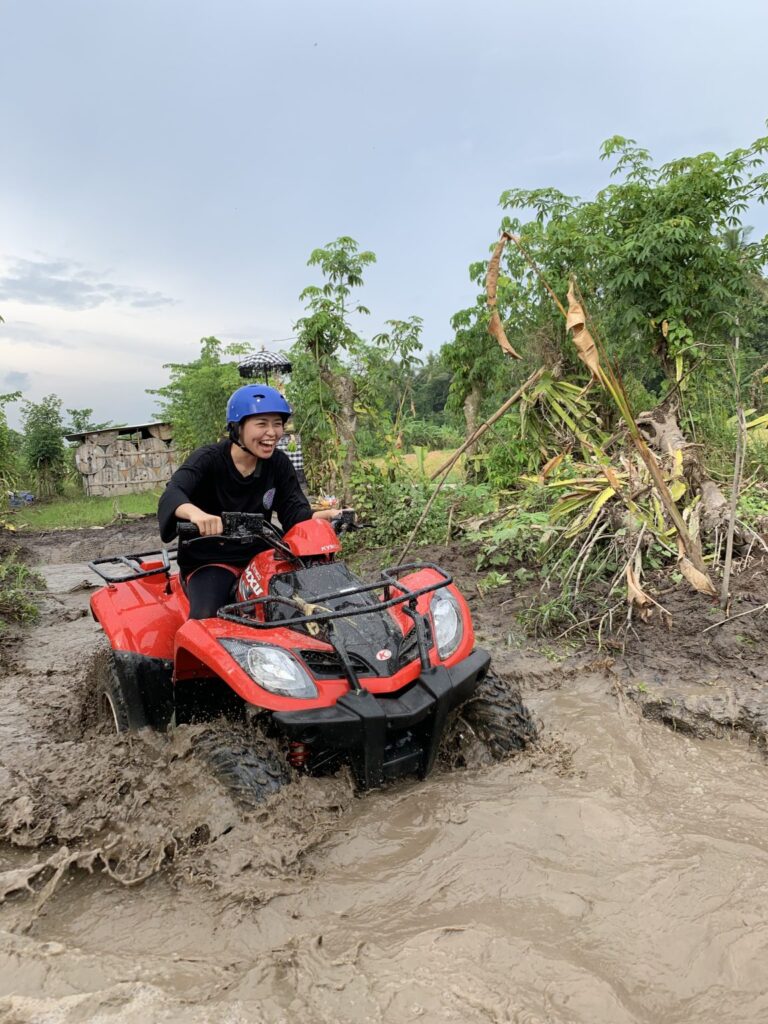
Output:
[218,562,454,690]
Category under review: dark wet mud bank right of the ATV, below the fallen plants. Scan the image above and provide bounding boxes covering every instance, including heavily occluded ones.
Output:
[450,540,768,752]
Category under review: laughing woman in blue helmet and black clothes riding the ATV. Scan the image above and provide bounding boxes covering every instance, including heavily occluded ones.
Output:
[158,384,339,618]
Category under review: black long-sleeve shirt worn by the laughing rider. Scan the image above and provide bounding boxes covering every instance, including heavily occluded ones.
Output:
[158,440,312,572]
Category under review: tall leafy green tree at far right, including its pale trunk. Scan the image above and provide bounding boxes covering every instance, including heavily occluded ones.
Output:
[468,136,768,529]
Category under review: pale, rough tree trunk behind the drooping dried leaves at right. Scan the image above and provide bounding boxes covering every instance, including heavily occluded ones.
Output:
[636,396,729,535]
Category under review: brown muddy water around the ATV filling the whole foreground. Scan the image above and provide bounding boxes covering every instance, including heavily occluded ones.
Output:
[0,528,768,1024]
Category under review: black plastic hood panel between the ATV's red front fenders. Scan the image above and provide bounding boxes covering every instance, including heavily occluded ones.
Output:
[266,562,432,679]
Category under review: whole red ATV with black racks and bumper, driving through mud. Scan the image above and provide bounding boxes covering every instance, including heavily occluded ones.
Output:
[89,513,536,802]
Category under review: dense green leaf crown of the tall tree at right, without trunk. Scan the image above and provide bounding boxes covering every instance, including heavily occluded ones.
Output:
[501,136,768,394]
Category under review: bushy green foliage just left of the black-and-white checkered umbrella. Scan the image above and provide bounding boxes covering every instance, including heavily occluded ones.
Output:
[147,338,252,459]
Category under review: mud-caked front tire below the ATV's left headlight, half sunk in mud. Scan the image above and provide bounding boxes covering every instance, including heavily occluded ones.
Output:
[195,723,291,807]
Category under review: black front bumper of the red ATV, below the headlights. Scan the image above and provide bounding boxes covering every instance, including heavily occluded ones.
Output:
[272,649,490,790]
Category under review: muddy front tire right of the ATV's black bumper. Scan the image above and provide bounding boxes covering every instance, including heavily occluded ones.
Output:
[441,672,538,768]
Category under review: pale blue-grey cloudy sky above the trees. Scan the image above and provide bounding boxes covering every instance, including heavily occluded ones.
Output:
[0,0,768,426]
